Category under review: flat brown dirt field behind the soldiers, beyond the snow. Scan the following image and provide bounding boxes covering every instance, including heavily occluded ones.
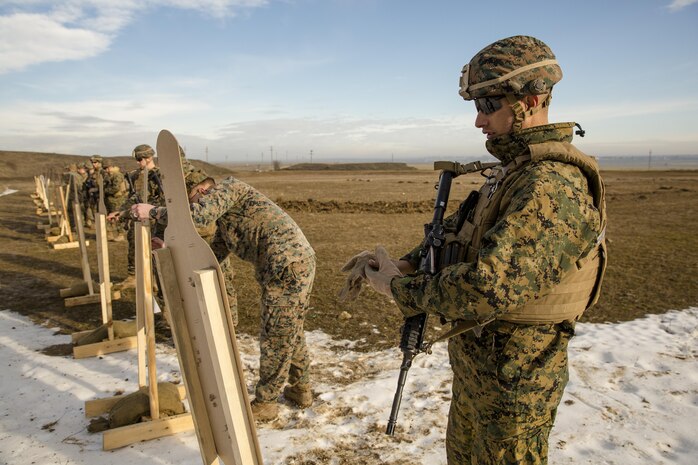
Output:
[0,168,698,350]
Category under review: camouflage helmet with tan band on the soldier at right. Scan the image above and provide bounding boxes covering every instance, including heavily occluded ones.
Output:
[458,36,562,100]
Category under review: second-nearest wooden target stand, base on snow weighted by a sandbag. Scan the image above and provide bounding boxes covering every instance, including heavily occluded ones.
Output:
[85,174,194,450]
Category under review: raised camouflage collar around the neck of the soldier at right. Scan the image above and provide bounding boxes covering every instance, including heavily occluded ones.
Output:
[485,123,574,165]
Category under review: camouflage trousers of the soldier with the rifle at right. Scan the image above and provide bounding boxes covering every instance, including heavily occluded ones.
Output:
[446,321,574,465]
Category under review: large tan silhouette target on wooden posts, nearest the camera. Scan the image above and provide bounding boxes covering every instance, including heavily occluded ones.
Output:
[155,130,263,465]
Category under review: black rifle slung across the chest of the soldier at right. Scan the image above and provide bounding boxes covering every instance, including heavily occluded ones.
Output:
[385,163,459,436]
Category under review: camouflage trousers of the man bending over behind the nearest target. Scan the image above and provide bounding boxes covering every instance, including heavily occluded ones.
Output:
[255,256,315,402]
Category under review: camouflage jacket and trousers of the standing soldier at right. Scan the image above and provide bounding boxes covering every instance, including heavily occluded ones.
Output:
[391,37,605,465]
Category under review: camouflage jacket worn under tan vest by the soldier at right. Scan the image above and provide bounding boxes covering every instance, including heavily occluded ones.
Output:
[391,124,605,321]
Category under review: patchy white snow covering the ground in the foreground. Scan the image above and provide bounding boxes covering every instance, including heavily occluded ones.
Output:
[0,308,698,465]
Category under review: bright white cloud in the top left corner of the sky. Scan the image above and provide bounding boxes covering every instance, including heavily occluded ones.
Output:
[0,0,268,74]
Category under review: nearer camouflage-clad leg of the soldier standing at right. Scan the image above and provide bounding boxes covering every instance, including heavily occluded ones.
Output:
[472,323,574,465]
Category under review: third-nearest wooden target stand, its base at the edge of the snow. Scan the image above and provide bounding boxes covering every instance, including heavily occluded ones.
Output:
[71,175,132,358]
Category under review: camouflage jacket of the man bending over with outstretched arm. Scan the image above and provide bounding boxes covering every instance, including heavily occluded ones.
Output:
[156,176,315,283]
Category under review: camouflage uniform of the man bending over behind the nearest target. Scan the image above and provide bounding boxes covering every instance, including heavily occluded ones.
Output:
[156,177,315,402]
